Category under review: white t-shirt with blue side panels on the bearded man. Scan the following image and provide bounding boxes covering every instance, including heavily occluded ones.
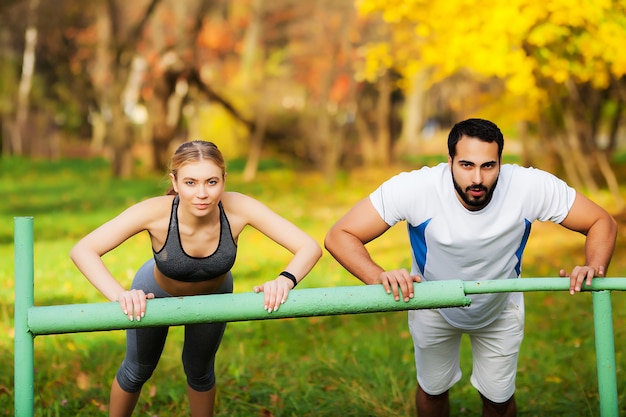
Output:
[370,163,576,330]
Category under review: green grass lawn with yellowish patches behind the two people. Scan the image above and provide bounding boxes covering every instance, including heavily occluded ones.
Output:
[0,154,626,417]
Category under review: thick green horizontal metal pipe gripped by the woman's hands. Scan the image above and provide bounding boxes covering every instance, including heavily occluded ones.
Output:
[28,280,471,335]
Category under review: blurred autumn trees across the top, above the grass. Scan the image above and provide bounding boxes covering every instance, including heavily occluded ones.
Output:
[0,0,626,202]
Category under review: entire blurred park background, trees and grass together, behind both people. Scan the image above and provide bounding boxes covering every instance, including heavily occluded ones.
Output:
[0,0,626,417]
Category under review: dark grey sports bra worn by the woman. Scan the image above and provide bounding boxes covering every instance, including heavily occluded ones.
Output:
[152,196,237,282]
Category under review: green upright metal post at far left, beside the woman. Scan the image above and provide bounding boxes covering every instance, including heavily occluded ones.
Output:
[13,217,35,417]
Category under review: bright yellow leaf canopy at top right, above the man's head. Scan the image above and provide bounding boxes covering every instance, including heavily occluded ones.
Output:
[357,0,626,118]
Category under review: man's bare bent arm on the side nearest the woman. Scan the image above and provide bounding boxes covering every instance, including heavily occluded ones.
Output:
[324,197,420,301]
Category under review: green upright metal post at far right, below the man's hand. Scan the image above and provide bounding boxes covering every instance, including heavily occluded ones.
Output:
[592,291,618,417]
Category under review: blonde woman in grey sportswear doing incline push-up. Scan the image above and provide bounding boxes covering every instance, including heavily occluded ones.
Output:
[70,141,322,416]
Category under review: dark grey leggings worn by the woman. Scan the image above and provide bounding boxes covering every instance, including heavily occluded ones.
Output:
[116,259,233,393]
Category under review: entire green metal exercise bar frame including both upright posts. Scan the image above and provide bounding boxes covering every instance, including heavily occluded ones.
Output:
[15,217,626,417]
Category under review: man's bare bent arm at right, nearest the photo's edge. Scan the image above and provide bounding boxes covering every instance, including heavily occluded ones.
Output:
[560,193,617,294]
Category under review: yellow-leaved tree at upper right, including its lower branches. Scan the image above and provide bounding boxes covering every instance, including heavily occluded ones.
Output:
[358,0,626,206]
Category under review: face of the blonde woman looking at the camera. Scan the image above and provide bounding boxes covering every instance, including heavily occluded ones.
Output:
[170,160,225,217]
